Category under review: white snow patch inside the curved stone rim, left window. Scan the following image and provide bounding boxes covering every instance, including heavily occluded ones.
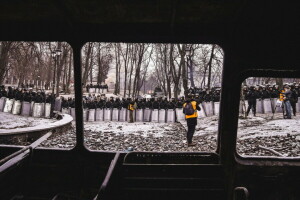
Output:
[0,112,57,130]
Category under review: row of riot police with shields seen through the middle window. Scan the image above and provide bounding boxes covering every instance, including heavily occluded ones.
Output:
[66,94,220,123]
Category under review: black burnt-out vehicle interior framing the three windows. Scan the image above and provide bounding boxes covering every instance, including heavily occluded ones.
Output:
[0,0,300,200]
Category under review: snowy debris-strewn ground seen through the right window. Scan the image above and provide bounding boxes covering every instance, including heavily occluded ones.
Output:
[237,113,300,157]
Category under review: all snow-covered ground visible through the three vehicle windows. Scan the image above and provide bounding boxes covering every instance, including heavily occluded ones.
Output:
[0,113,300,157]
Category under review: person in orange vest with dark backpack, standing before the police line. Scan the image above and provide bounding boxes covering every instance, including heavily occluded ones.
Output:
[183,96,200,147]
